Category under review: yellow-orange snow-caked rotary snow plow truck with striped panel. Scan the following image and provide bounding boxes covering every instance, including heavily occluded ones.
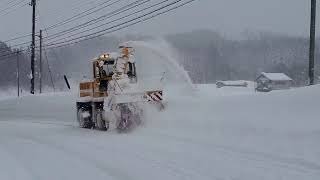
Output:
[76,46,163,132]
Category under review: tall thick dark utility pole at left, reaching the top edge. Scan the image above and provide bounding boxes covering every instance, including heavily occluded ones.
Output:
[30,0,37,94]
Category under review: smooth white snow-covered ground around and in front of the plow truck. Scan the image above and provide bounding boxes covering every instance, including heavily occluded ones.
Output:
[0,85,320,180]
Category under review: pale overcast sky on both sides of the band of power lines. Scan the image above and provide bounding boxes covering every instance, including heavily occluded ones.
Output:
[0,0,320,43]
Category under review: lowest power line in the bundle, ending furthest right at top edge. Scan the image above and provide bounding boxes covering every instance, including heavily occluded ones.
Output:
[47,0,196,49]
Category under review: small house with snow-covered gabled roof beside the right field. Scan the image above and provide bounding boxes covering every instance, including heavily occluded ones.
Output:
[255,72,293,92]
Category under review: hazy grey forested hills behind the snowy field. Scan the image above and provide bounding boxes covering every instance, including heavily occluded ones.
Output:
[0,30,320,91]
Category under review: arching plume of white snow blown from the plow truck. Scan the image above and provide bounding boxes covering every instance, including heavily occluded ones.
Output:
[127,39,194,92]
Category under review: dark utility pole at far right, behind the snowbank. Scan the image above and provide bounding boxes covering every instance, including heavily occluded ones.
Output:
[309,0,316,85]
